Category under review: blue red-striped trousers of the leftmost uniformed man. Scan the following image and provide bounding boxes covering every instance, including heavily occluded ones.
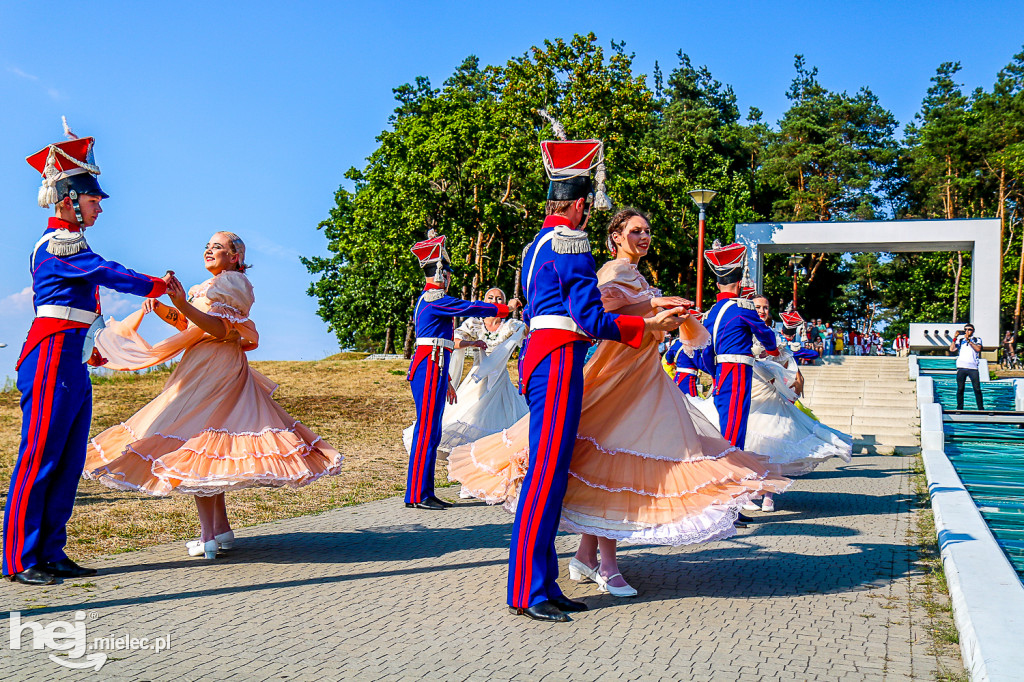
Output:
[3,330,92,576]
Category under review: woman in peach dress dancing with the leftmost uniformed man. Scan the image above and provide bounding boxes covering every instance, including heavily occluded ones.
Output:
[84,232,343,559]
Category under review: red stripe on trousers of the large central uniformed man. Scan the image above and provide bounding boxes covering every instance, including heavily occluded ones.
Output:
[514,345,572,606]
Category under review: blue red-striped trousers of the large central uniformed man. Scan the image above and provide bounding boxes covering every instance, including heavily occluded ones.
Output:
[508,341,589,608]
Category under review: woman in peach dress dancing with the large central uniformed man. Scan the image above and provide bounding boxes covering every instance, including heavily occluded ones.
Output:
[449,209,790,596]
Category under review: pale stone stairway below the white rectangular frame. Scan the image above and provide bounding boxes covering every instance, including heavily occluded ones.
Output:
[800,355,921,454]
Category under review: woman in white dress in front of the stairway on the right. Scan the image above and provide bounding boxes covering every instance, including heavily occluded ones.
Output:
[689,296,853,512]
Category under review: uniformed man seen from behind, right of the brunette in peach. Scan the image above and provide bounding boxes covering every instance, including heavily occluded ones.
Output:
[700,241,778,449]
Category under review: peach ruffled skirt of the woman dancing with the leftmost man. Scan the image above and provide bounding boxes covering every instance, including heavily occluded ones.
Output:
[84,332,343,496]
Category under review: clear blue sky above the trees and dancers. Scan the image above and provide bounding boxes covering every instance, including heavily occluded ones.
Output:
[0,0,1024,360]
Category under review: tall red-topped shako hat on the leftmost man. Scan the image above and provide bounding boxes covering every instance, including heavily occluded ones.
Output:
[26,117,109,222]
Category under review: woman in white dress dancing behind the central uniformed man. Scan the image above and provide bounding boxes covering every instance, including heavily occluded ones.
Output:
[402,288,529,452]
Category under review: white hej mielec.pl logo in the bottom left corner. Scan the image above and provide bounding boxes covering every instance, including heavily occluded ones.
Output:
[8,611,171,671]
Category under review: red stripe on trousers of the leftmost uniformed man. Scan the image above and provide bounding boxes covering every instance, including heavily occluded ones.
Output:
[4,334,63,573]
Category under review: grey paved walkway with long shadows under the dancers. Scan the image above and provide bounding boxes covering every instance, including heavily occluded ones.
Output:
[0,448,958,681]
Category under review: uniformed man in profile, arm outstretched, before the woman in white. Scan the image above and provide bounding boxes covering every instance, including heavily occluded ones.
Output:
[406,230,519,510]
